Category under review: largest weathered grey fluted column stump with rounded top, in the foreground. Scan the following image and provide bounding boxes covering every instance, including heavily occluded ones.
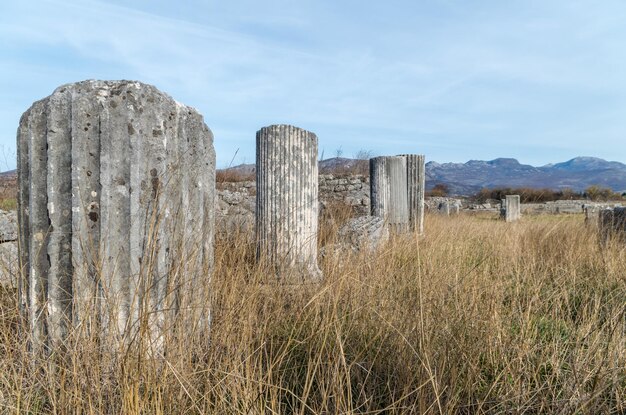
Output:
[17,81,215,350]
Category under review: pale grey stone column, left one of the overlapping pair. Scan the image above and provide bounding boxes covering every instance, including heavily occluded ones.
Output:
[370,156,410,233]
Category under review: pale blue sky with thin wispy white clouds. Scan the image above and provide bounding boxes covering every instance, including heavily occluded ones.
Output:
[0,0,626,170]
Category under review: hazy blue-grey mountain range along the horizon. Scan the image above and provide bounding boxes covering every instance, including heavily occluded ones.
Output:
[0,157,626,195]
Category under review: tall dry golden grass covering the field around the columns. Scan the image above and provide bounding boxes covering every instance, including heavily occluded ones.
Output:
[0,216,626,414]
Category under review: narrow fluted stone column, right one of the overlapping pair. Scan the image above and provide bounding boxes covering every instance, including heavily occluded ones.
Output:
[404,154,426,235]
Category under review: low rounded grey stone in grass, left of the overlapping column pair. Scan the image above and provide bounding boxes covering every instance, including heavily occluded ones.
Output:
[339,216,389,251]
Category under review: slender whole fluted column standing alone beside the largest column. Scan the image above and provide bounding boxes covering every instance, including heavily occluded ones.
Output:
[256,125,321,280]
